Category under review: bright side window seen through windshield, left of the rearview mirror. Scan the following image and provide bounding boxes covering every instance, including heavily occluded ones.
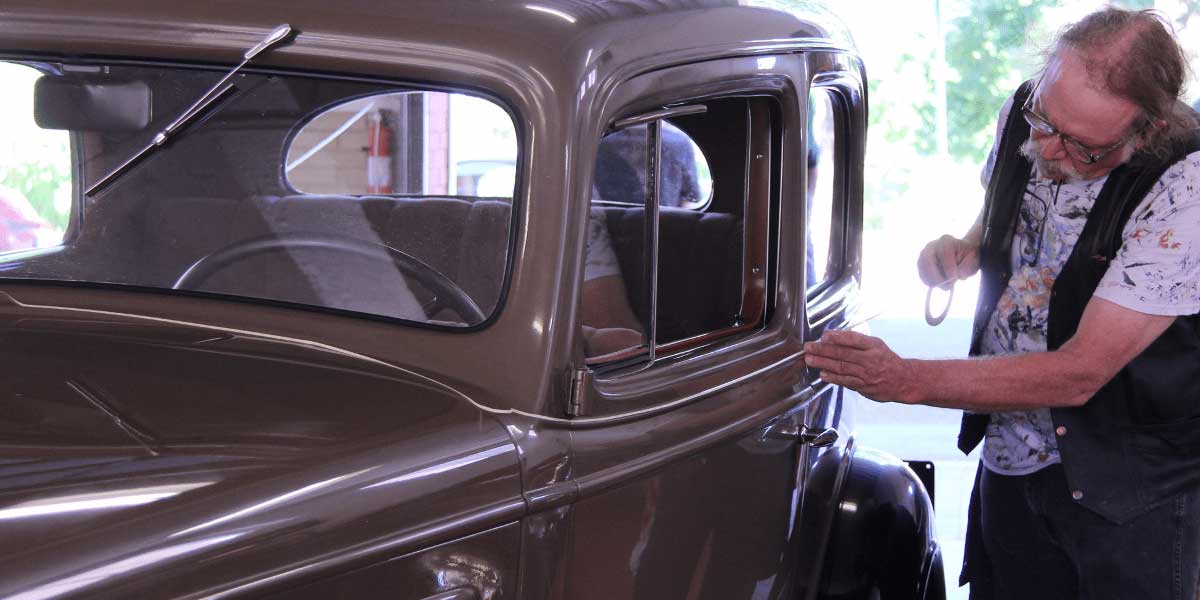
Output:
[0,62,73,253]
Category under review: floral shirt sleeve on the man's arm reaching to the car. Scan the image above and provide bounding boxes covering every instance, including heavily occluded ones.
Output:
[1094,152,1200,316]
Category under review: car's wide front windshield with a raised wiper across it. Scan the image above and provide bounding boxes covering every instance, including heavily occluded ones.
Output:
[0,60,518,326]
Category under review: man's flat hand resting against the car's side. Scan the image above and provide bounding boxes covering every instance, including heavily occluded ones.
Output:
[804,331,919,404]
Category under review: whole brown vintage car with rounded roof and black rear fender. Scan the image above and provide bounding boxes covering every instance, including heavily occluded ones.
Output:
[0,0,944,600]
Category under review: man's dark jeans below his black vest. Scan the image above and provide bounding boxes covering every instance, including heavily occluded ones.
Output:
[971,464,1200,600]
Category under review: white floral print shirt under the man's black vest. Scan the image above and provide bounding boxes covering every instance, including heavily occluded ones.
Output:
[982,98,1200,475]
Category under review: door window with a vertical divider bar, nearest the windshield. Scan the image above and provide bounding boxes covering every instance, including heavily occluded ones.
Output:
[582,98,772,364]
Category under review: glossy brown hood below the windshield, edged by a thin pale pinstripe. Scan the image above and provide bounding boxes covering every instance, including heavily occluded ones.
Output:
[0,289,523,598]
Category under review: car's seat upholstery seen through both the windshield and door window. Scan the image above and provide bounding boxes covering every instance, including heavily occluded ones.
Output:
[144,194,742,333]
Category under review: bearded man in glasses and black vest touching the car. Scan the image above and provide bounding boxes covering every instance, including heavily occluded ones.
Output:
[805,8,1200,600]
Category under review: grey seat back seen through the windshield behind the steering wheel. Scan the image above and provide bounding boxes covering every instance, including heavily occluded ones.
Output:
[145,194,511,319]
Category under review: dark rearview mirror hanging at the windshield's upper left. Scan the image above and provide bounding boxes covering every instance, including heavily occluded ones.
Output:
[34,74,151,131]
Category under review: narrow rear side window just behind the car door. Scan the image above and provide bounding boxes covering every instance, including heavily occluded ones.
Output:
[804,88,840,292]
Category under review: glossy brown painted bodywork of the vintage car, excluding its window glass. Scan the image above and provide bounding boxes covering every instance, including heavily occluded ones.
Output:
[0,0,940,600]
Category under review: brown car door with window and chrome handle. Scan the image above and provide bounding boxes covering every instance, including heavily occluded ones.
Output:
[563,55,844,599]
